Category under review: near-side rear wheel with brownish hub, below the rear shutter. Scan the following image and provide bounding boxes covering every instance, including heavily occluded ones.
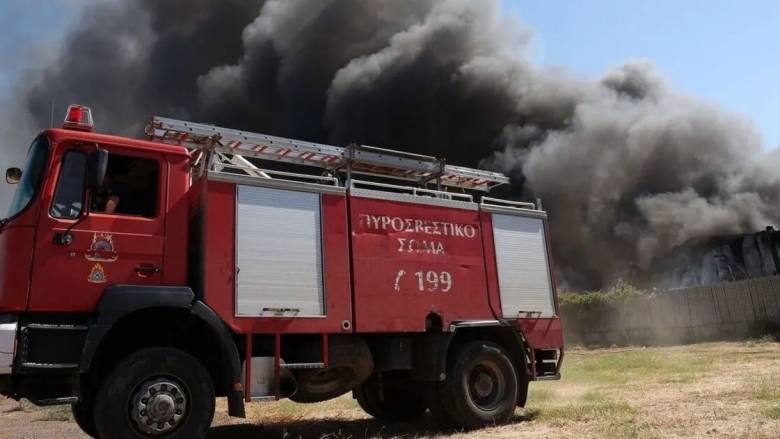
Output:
[439,341,518,428]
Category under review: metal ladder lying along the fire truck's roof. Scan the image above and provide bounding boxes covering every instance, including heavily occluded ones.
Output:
[146,116,509,192]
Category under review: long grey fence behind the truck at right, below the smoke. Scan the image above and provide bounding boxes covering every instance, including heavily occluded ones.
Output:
[561,276,780,345]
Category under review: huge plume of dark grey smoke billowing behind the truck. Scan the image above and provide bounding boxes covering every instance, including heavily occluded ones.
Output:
[6,0,780,289]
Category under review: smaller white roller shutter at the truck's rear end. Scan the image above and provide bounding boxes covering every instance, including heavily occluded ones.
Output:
[493,213,555,318]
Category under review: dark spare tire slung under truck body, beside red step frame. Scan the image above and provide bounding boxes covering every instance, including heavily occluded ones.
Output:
[290,336,374,403]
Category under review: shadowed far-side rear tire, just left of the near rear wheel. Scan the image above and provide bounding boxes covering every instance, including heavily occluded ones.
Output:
[352,375,428,421]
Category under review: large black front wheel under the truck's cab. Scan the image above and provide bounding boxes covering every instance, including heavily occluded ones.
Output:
[95,347,215,439]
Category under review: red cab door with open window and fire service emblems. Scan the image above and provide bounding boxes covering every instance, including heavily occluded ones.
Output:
[30,144,167,312]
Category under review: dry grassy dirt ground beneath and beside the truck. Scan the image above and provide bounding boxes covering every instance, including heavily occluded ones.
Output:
[0,338,780,439]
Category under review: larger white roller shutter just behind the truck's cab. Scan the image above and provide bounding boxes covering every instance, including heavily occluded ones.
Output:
[236,186,324,316]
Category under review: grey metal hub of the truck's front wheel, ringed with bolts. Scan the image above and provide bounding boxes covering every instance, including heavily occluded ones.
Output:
[130,378,187,436]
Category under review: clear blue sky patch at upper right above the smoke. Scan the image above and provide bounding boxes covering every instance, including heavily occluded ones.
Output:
[502,0,780,148]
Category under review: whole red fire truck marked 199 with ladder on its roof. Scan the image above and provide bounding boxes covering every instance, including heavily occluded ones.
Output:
[0,105,563,438]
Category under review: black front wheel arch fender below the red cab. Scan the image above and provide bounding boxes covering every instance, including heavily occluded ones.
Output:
[79,285,245,417]
